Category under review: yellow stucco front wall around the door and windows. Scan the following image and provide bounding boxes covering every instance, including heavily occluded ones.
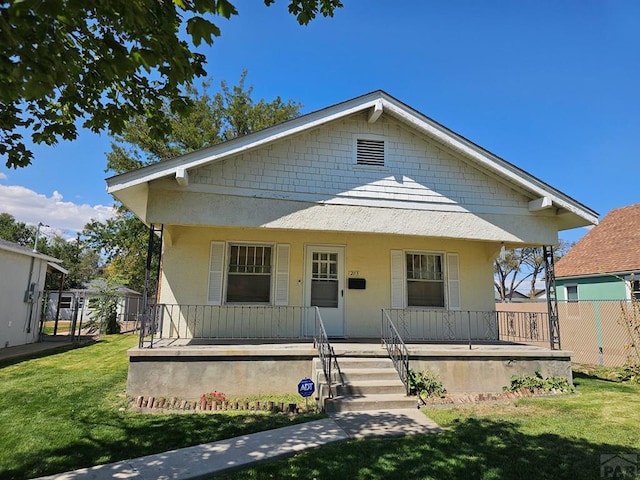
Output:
[160,226,495,337]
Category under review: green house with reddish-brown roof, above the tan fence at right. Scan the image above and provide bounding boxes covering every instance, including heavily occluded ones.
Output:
[555,203,640,302]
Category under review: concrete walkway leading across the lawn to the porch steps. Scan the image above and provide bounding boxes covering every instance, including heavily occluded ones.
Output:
[33,409,442,480]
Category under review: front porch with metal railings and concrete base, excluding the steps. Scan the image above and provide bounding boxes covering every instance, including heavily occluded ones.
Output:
[127,305,571,400]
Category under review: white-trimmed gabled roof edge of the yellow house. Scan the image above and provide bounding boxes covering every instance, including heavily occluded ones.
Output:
[107,90,598,230]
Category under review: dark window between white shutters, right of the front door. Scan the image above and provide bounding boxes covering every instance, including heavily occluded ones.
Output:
[406,253,444,307]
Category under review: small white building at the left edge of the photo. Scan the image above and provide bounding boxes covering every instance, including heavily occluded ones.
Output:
[0,239,67,348]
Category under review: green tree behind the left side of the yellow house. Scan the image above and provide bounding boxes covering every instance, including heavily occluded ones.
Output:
[83,75,301,291]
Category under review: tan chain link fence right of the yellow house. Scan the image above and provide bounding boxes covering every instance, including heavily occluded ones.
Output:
[496,300,631,367]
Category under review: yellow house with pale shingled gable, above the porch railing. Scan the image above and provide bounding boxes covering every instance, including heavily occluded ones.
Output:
[107,91,597,338]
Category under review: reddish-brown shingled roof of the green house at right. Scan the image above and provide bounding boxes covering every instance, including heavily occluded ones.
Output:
[555,203,640,277]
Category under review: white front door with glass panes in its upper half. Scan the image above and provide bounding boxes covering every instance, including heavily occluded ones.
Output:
[304,245,344,337]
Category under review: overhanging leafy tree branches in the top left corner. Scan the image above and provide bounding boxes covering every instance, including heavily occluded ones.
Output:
[0,0,342,168]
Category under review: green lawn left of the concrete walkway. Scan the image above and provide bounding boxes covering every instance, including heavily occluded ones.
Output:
[0,335,319,479]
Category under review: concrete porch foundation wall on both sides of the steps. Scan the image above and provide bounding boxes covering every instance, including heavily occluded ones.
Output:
[127,347,572,400]
